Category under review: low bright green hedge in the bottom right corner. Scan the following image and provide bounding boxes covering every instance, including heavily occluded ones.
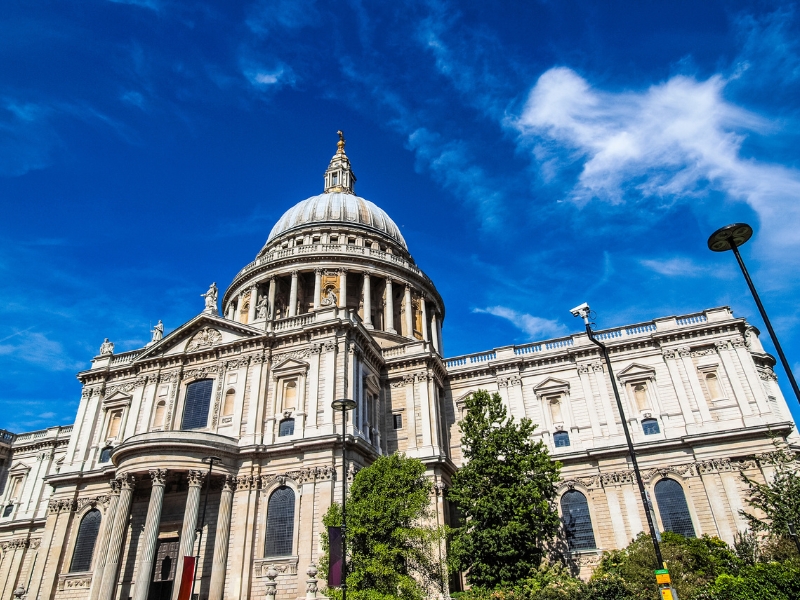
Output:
[698,562,800,600]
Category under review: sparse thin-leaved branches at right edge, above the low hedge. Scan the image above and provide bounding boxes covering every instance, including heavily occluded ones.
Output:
[740,441,800,552]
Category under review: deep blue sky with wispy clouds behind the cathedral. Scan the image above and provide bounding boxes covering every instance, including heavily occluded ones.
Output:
[0,0,800,431]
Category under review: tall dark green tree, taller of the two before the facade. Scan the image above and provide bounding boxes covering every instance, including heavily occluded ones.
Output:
[447,390,560,588]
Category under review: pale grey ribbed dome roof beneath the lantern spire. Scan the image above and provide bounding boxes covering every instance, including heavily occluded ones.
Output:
[267,192,408,251]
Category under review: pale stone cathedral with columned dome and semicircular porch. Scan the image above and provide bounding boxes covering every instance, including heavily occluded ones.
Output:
[0,137,796,600]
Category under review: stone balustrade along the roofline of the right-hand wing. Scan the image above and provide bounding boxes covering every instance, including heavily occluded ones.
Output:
[445,308,730,369]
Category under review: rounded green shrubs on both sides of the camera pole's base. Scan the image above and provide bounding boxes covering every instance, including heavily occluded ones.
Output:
[593,532,740,600]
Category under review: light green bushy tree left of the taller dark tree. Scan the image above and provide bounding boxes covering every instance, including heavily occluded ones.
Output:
[322,454,444,600]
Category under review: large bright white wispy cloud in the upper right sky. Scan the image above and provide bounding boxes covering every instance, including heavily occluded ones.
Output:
[510,67,800,264]
